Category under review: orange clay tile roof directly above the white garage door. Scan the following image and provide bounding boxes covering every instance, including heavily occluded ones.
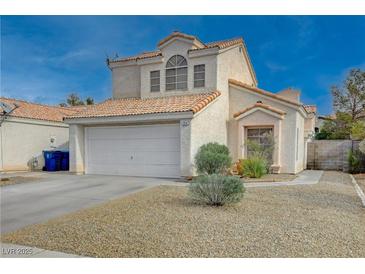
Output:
[66,91,221,119]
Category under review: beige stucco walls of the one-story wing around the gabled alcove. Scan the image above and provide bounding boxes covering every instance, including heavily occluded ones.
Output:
[228,86,305,173]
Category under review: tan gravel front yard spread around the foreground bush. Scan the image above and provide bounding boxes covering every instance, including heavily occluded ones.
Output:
[2,172,365,257]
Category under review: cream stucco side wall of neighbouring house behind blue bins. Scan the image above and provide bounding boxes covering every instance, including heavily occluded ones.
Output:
[0,118,68,171]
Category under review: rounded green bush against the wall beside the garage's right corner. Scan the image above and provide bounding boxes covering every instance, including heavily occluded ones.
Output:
[195,143,232,174]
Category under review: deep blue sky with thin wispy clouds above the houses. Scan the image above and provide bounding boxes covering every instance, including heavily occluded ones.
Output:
[0,16,365,114]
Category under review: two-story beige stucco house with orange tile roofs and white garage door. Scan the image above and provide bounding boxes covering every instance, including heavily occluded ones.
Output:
[65,32,314,177]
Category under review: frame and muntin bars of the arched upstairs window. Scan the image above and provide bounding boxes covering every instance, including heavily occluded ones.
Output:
[165,54,189,91]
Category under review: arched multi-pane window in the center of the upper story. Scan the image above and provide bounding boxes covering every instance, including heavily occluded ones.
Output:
[166,55,188,90]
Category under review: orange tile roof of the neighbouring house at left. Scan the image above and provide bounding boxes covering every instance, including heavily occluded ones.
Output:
[0,97,81,122]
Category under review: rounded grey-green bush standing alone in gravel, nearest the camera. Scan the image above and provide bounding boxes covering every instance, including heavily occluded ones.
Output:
[189,174,245,206]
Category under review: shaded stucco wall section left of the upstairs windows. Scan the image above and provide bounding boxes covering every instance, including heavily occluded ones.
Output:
[112,65,141,98]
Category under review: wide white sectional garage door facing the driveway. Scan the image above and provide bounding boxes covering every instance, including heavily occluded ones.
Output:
[85,124,180,177]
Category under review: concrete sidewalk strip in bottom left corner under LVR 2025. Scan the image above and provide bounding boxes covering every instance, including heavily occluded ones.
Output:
[0,243,83,258]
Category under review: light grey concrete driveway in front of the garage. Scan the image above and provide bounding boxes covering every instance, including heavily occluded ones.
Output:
[0,172,176,233]
